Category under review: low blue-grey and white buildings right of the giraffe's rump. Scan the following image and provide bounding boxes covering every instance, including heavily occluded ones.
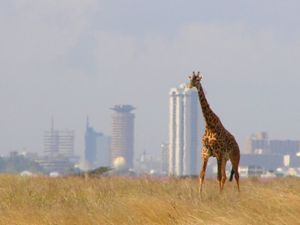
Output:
[240,132,300,176]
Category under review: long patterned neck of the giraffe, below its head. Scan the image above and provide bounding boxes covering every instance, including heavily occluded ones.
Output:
[197,83,220,128]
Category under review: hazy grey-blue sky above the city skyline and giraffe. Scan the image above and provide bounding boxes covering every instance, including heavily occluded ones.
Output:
[0,0,300,158]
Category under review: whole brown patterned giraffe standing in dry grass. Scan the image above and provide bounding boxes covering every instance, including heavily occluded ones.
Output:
[189,72,240,193]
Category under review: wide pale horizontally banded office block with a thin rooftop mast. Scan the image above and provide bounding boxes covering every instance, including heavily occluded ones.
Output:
[44,119,74,157]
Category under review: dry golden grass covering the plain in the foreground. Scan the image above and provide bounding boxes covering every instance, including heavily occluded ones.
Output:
[0,175,300,225]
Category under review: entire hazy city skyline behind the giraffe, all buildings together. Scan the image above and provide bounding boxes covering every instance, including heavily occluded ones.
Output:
[0,84,300,177]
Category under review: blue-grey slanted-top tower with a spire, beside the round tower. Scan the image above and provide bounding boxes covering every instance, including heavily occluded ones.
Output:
[84,120,111,167]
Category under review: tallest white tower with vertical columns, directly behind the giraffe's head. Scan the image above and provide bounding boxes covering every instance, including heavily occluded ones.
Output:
[168,84,200,176]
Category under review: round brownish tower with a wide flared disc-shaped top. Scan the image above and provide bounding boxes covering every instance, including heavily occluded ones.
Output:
[111,105,135,168]
